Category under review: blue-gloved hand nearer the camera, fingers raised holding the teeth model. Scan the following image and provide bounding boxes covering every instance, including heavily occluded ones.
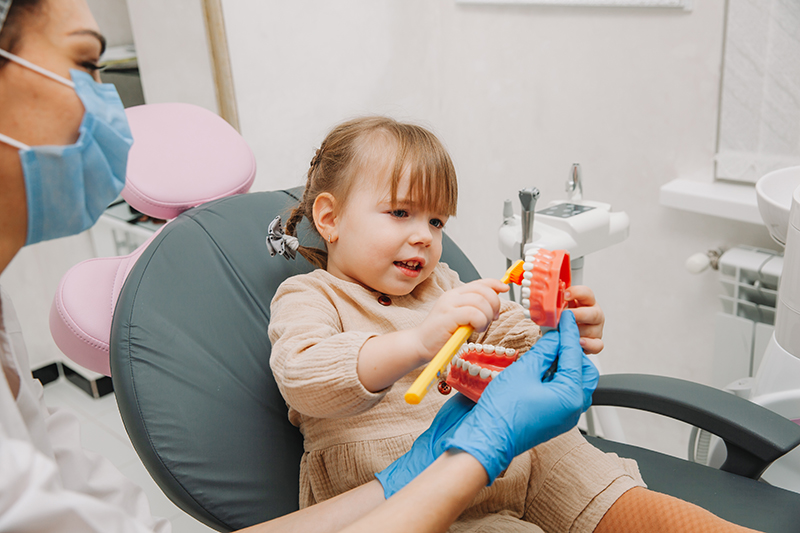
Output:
[437,310,598,485]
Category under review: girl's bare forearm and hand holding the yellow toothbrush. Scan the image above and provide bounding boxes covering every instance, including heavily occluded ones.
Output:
[358,279,508,392]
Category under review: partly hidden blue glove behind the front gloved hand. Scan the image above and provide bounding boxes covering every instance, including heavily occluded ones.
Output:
[375,394,475,500]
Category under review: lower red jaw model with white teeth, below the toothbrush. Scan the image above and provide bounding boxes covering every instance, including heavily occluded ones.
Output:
[447,343,519,402]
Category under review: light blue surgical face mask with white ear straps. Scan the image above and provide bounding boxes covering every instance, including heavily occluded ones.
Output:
[0,50,133,245]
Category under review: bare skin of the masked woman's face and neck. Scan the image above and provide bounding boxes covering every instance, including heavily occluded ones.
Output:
[0,0,105,260]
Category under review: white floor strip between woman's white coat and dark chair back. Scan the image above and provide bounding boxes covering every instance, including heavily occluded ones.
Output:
[44,377,214,533]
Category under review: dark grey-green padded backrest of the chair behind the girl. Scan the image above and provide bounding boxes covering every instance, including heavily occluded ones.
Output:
[111,189,478,531]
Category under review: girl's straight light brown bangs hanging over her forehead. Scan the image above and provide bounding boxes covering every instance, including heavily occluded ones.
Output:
[390,124,458,217]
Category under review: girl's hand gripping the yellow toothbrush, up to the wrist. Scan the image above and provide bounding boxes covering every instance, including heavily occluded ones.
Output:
[413,279,508,364]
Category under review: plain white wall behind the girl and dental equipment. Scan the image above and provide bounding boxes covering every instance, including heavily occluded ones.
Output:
[217,0,773,455]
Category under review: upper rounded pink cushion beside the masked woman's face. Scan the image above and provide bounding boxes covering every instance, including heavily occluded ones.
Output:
[122,103,256,220]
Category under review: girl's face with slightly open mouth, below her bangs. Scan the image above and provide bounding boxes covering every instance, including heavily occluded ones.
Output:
[323,167,448,296]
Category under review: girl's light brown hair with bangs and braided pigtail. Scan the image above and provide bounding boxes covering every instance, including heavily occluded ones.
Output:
[285,117,458,268]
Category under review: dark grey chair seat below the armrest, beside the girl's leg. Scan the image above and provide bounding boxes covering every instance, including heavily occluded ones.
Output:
[587,437,800,533]
